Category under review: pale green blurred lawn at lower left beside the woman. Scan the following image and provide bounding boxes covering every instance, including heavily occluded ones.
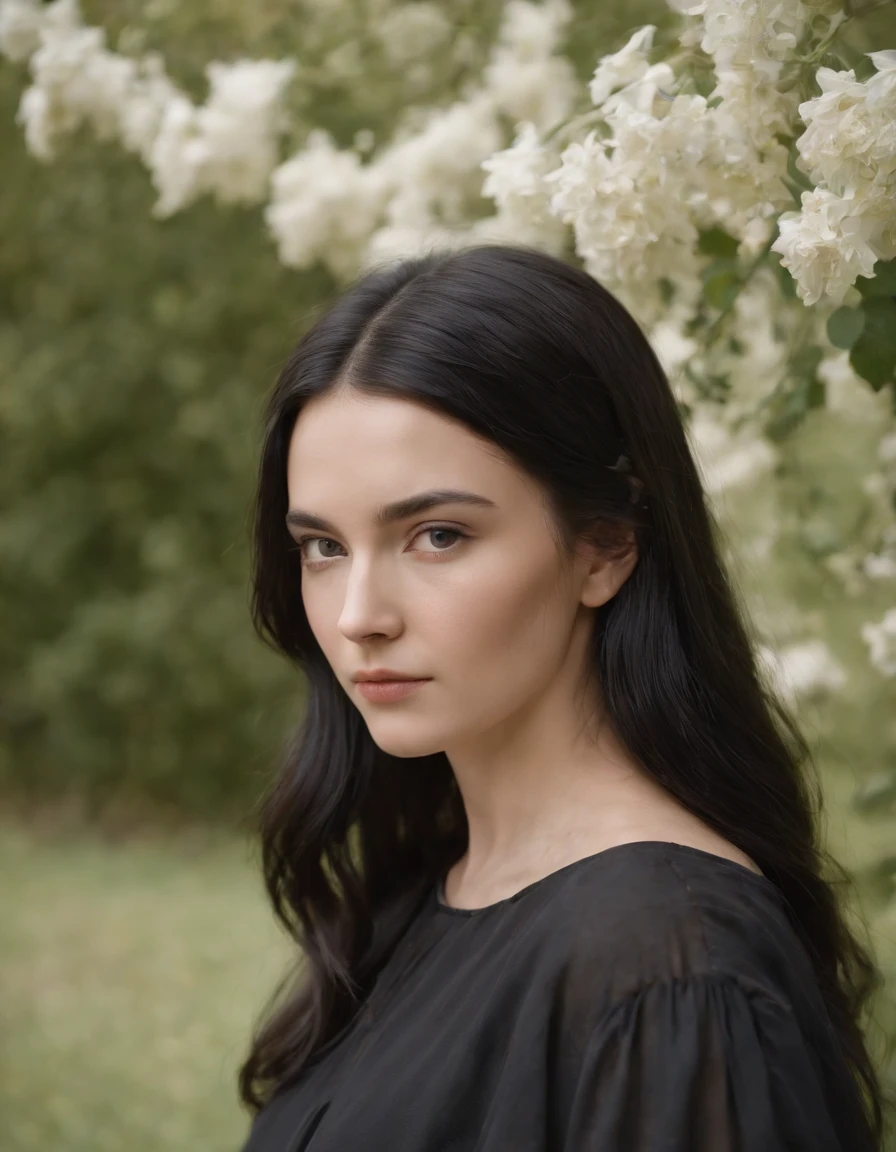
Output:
[0,824,289,1152]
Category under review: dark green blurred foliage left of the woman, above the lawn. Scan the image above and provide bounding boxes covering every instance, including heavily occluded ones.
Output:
[0,69,313,816]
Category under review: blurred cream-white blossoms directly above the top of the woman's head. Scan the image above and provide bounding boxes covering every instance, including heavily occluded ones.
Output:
[265,0,576,279]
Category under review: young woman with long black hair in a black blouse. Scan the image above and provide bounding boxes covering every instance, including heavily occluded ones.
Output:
[233,238,882,1152]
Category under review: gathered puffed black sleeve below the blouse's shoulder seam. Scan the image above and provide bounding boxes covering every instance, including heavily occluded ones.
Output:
[562,973,853,1152]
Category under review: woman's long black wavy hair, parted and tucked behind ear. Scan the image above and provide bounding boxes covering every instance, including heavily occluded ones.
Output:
[233,244,883,1142]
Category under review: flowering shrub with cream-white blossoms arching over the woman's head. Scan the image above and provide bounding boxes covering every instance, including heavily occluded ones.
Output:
[0,0,896,843]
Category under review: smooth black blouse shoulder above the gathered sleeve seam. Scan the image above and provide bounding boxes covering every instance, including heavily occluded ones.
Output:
[536,841,813,1001]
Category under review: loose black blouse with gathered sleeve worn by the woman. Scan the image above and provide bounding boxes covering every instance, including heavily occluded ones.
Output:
[243,841,871,1152]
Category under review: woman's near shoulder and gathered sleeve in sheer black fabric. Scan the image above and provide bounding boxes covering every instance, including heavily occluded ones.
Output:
[536,842,868,1152]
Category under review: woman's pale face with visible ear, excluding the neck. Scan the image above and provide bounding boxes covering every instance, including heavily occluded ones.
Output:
[287,392,621,757]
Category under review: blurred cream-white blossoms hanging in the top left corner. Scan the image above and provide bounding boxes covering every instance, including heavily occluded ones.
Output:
[0,0,295,217]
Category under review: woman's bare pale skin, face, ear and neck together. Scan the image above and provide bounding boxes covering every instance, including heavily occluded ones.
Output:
[287,389,759,908]
